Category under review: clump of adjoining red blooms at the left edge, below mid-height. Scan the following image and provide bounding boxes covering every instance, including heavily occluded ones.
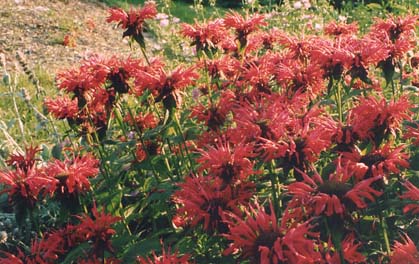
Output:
[0,147,99,222]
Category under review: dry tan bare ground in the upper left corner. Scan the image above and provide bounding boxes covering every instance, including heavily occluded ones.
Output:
[0,0,134,74]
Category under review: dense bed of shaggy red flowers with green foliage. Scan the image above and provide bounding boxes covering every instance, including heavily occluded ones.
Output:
[0,2,419,263]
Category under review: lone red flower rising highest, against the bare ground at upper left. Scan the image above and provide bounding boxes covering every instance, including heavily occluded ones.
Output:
[106,2,157,46]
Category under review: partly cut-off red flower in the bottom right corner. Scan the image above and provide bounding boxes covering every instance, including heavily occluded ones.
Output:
[390,234,419,264]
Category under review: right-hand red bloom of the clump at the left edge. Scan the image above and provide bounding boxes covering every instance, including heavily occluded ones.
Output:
[46,154,99,194]
